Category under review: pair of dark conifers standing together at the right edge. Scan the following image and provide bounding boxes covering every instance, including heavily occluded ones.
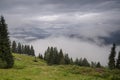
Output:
[108,44,120,69]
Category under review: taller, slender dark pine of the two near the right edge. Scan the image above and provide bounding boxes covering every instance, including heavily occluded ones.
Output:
[108,44,116,69]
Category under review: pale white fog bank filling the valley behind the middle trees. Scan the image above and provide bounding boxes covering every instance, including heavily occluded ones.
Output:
[28,37,110,65]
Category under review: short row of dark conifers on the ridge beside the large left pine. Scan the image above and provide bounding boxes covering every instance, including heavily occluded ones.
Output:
[11,41,35,56]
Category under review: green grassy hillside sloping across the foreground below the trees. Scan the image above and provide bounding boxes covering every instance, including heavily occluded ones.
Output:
[0,54,120,80]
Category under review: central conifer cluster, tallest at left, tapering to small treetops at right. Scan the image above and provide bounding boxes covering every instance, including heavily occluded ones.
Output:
[38,47,101,67]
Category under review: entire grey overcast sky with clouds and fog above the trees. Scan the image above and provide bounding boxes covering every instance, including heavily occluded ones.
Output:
[0,0,120,64]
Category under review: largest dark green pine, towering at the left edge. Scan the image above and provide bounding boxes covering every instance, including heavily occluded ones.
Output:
[0,16,14,68]
